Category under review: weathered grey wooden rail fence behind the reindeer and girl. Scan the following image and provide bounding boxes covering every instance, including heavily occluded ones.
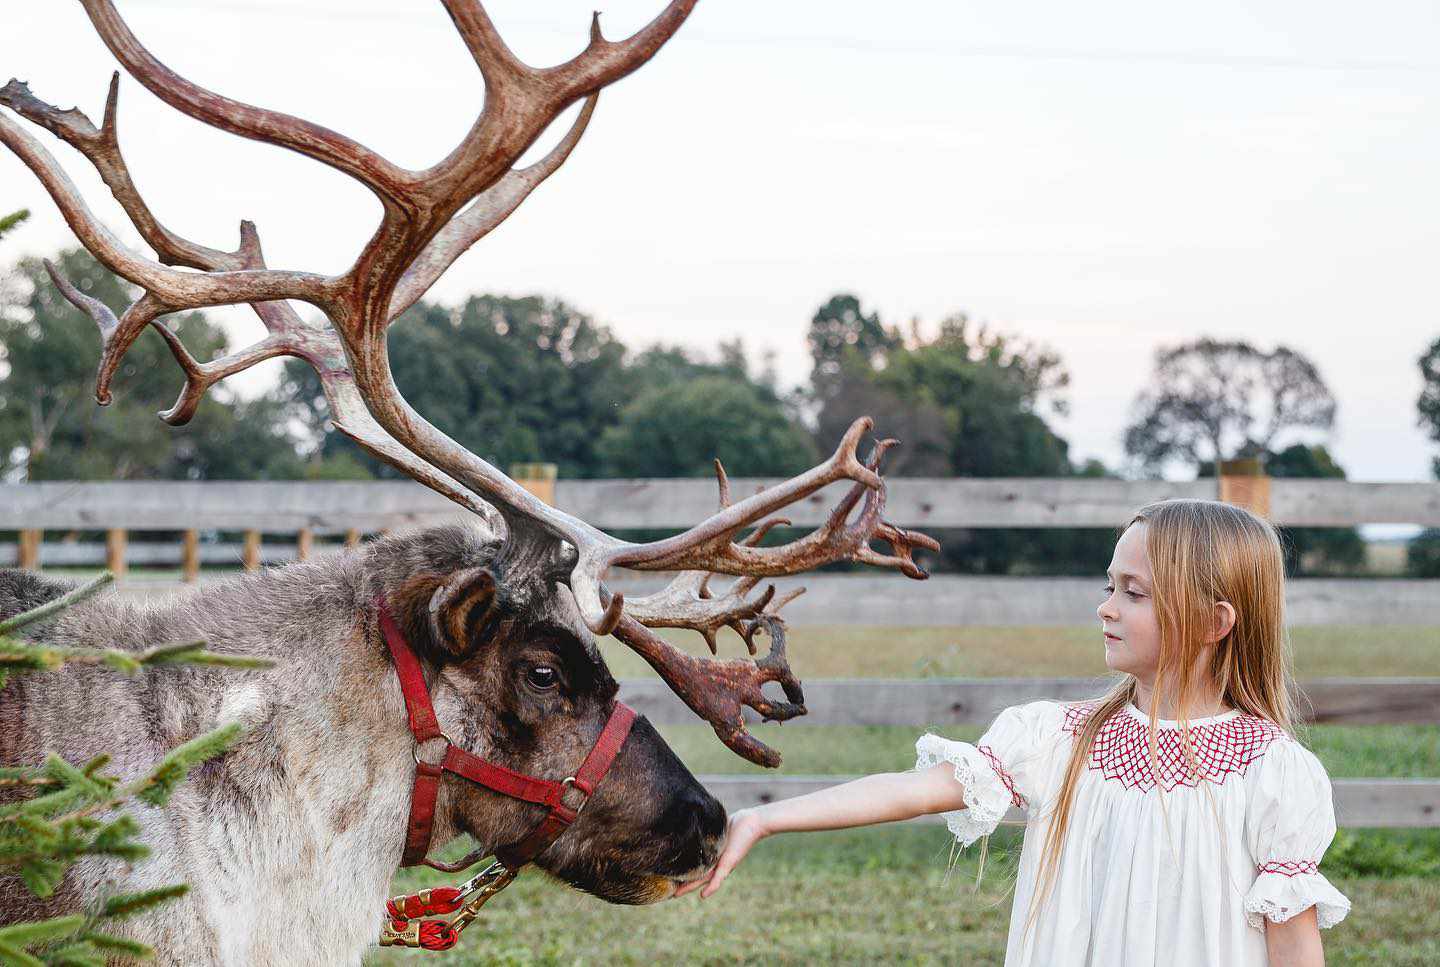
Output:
[0,478,1440,826]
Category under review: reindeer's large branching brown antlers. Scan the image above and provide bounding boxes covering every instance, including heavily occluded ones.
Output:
[0,0,936,761]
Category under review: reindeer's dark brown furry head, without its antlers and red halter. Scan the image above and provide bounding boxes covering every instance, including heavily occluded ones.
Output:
[364,525,724,902]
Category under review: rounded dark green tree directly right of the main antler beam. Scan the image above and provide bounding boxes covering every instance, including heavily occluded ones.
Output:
[283,295,629,478]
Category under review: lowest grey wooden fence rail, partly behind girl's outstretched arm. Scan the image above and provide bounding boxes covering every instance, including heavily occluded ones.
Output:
[698,776,1440,827]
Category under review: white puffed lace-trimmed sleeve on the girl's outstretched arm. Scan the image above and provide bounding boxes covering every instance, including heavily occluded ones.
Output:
[914,702,1063,846]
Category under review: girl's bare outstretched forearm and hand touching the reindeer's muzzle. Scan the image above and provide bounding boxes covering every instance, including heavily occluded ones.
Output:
[675,763,965,898]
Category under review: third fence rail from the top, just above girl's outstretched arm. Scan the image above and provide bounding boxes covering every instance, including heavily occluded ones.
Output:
[621,678,1440,728]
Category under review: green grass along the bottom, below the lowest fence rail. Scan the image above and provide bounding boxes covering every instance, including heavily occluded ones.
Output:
[366,826,1440,967]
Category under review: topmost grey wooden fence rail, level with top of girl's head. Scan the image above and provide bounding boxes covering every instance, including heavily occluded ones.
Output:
[0,478,1440,532]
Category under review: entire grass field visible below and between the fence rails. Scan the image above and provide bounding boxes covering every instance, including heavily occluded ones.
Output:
[366,627,1440,967]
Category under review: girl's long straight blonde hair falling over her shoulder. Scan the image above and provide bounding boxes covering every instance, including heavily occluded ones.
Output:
[1030,501,1293,921]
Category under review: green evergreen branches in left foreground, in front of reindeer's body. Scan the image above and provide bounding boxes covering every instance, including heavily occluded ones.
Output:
[0,574,269,967]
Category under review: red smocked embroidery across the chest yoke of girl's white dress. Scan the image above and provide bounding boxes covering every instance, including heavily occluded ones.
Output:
[1064,702,1284,793]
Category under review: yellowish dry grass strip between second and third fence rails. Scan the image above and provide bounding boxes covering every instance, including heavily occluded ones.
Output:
[600,626,1440,679]
